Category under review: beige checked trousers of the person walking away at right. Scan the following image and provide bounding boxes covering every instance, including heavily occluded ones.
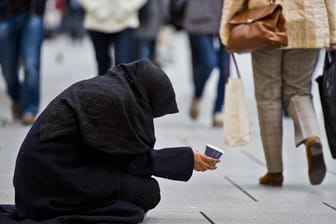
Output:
[252,49,320,173]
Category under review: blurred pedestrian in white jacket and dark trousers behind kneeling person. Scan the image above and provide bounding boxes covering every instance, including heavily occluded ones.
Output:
[79,0,146,75]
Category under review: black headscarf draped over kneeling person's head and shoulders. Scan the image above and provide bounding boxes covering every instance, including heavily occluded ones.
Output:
[40,60,178,154]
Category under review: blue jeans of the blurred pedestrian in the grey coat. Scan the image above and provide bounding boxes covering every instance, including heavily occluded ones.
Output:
[189,34,229,113]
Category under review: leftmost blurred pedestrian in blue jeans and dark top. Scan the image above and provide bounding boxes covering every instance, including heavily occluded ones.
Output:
[0,0,46,125]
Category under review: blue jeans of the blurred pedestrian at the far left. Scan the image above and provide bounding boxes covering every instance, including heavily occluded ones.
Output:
[0,13,44,115]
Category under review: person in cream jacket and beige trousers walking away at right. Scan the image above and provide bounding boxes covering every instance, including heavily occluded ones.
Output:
[221,0,336,186]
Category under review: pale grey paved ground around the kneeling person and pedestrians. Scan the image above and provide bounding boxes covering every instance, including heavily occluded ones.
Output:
[0,32,336,224]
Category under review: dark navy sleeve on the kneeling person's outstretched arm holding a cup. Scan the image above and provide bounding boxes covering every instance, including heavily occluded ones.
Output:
[127,147,194,181]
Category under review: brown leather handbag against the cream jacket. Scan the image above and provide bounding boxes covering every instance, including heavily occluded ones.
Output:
[226,1,288,53]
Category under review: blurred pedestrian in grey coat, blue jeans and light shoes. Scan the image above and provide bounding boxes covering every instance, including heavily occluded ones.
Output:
[183,0,229,127]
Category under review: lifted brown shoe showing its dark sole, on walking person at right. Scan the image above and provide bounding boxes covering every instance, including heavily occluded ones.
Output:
[304,136,326,185]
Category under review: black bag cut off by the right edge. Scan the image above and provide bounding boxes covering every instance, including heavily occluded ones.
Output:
[316,51,336,159]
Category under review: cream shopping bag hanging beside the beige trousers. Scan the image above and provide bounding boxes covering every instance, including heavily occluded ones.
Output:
[223,53,251,146]
